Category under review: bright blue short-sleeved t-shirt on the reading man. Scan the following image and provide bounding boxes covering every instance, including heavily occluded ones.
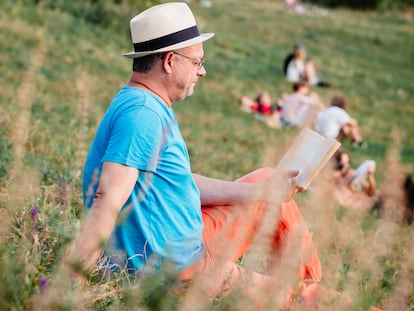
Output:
[83,86,204,271]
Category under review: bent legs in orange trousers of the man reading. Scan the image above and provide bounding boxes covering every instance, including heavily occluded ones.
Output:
[182,168,322,302]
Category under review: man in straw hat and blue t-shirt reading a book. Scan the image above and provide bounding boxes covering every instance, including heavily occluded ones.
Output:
[70,3,322,308]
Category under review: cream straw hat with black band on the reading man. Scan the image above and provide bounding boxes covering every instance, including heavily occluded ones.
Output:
[122,2,214,58]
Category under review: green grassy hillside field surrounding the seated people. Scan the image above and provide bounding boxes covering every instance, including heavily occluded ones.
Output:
[0,0,414,310]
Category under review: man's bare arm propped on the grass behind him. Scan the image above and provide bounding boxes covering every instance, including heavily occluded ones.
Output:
[68,162,138,269]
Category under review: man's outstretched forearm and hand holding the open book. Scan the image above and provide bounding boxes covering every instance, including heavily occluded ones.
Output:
[193,171,298,206]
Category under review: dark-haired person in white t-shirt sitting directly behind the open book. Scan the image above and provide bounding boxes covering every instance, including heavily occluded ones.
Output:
[315,96,367,148]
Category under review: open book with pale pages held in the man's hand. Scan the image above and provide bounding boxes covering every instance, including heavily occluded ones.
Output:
[276,127,341,189]
